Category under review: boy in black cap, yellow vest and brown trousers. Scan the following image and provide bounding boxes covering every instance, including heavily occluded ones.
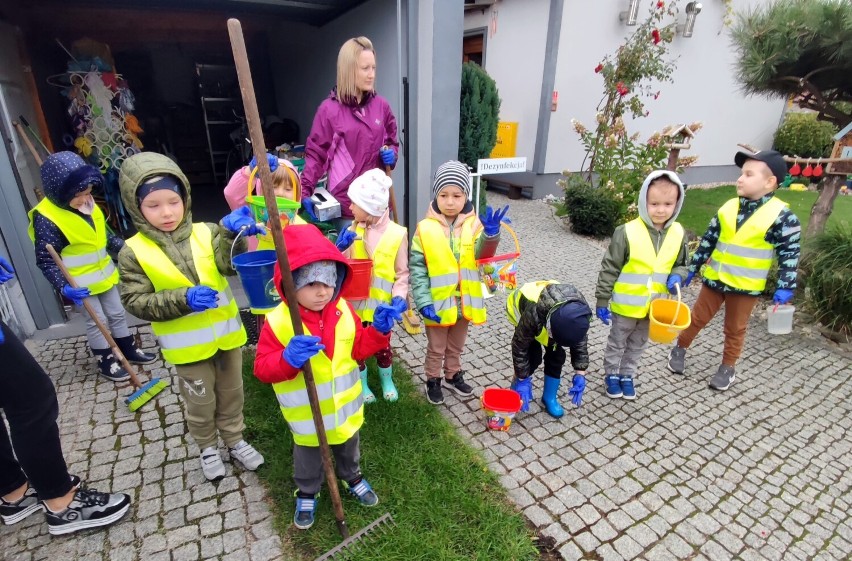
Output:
[666,150,802,391]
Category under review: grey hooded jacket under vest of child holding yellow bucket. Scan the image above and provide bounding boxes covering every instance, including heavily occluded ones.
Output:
[595,170,689,308]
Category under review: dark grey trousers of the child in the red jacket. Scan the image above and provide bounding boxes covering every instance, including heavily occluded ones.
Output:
[293,432,361,495]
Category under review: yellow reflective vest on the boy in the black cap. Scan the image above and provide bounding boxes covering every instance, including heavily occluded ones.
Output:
[704,197,787,291]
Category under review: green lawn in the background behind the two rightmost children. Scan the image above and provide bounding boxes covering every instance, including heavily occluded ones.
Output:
[677,185,852,237]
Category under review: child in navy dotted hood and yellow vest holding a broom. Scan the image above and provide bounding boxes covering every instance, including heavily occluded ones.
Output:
[29,152,157,382]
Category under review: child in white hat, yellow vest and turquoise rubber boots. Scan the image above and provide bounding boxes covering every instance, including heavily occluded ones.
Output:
[337,169,408,403]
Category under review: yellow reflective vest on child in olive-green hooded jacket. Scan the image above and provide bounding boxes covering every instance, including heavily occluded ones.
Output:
[127,223,247,364]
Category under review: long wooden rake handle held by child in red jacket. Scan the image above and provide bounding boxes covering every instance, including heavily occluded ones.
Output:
[228,18,349,539]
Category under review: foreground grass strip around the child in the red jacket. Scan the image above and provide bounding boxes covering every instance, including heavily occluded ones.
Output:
[243,351,539,561]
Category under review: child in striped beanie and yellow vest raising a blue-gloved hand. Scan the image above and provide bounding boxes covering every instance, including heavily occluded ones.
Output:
[408,160,502,405]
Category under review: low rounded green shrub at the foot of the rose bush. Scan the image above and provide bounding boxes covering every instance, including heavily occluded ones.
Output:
[559,175,620,238]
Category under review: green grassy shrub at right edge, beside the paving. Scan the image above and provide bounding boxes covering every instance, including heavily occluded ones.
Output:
[800,223,852,337]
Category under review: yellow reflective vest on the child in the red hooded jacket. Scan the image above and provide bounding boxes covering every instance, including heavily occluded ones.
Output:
[266,298,364,446]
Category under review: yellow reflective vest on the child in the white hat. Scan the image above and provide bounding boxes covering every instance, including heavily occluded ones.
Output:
[350,222,406,321]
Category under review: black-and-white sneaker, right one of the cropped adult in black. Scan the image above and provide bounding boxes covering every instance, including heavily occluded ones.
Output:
[41,489,130,536]
